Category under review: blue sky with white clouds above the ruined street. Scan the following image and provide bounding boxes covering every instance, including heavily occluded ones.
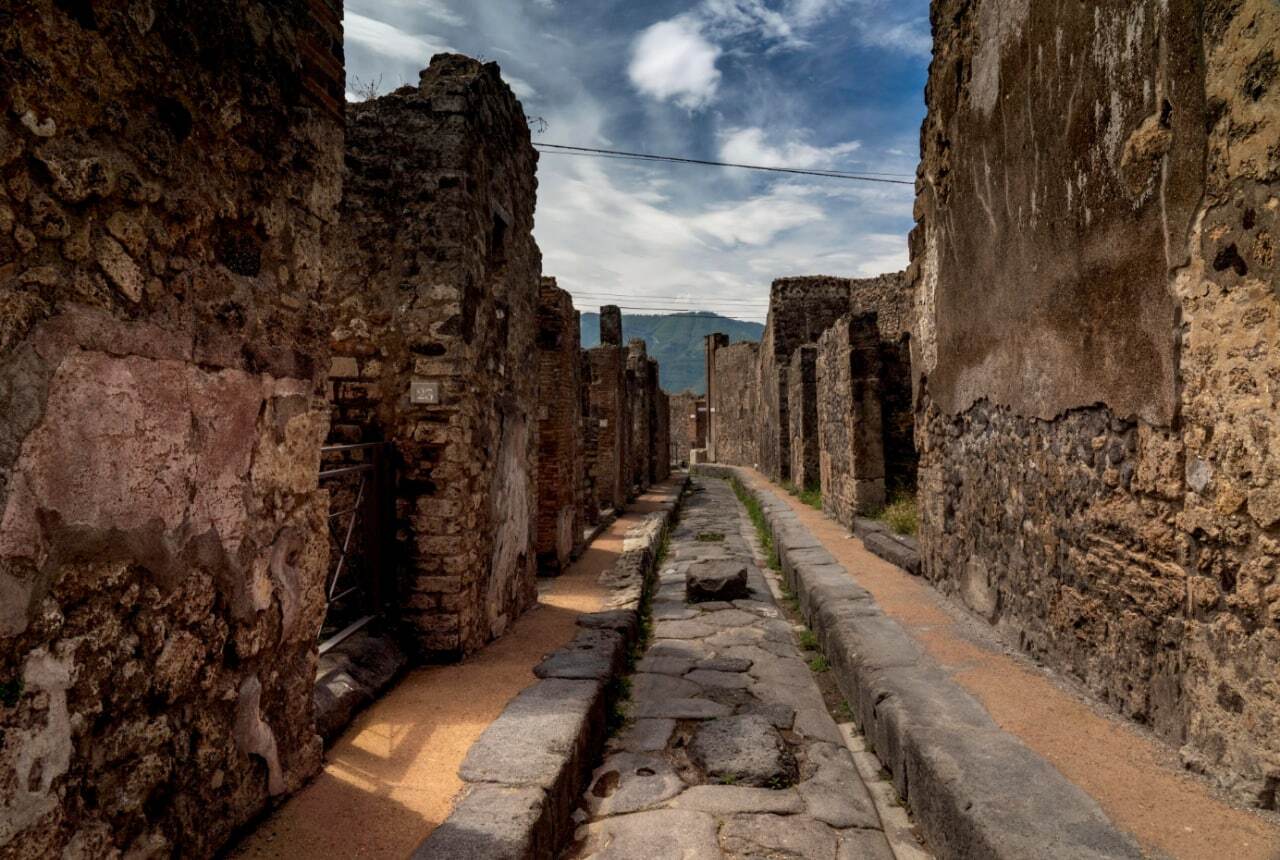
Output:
[346,0,929,320]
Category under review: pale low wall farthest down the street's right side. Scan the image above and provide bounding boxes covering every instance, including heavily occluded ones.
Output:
[709,342,760,466]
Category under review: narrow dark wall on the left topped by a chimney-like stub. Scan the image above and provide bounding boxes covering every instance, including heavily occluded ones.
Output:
[588,305,631,511]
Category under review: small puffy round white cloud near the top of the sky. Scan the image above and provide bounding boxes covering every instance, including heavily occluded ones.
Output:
[627,17,721,110]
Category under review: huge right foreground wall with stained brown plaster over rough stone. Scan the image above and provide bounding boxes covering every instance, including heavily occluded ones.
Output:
[910,0,1280,808]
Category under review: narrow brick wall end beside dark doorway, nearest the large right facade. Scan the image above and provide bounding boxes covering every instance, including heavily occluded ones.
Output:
[814,314,884,527]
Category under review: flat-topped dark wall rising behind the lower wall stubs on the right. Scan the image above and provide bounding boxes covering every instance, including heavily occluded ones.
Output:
[759,275,851,481]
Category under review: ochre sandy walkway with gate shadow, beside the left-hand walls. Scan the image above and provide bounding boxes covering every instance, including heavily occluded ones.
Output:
[232,484,676,860]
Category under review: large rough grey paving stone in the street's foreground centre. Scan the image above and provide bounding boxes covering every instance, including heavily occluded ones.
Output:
[689,714,796,787]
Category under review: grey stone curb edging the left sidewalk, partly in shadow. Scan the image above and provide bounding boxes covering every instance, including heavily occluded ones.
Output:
[412,477,687,860]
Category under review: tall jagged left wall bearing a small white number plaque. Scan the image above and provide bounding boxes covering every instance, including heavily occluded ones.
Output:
[332,55,541,659]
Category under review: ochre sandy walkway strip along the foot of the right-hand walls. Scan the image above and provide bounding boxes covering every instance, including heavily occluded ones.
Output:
[748,471,1280,860]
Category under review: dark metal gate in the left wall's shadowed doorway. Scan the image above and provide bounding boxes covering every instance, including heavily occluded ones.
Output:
[320,442,393,654]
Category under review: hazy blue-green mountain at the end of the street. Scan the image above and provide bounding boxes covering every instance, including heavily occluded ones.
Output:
[582,311,764,394]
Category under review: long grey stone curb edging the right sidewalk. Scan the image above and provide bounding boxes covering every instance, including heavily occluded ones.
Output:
[695,467,1142,860]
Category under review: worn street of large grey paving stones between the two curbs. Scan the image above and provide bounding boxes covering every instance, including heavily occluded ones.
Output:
[566,479,927,860]
